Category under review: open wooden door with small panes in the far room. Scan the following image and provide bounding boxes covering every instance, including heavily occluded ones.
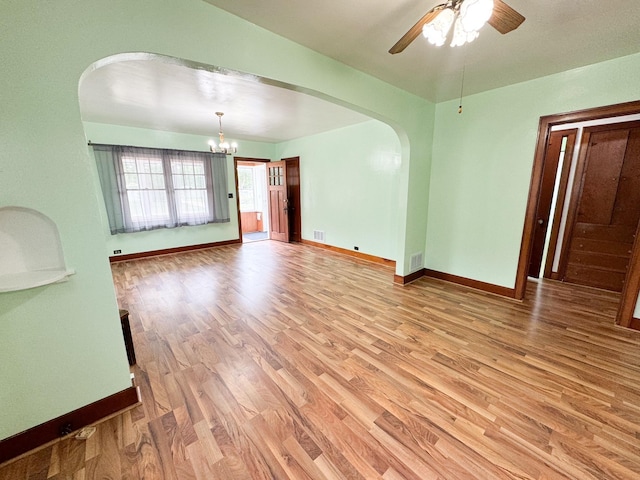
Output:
[267,161,289,242]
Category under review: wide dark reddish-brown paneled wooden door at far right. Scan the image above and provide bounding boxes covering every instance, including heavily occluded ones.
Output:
[562,122,640,292]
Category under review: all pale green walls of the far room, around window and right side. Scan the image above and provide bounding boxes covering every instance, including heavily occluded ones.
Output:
[84,120,401,260]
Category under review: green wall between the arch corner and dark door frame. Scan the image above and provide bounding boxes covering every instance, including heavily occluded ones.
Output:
[425,54,640,287]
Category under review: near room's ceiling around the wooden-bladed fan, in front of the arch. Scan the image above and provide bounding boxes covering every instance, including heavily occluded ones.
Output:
[205,0,640,102]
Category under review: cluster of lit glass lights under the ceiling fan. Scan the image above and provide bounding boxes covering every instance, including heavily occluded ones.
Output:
[422,0,493,47]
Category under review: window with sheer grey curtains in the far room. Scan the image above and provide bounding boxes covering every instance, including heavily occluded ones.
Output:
[93,145,229,234]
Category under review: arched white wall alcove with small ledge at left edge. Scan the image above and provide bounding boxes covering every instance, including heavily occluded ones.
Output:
[0,206,75,292]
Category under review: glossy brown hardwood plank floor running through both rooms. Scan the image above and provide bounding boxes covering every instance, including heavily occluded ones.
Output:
[0,242,640,480]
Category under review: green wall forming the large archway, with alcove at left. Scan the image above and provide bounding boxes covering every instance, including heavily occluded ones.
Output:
[0,0,435,438]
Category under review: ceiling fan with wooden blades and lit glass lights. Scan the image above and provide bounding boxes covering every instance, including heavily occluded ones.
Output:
[389,0,525,54]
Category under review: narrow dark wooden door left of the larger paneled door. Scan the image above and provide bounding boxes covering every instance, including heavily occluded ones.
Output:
[528,129,577,278]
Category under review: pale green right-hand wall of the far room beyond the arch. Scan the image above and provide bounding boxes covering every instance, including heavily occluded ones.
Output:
[277,120,401,260]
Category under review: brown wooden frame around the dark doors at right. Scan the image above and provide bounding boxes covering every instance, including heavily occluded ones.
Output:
[514,100,640,327]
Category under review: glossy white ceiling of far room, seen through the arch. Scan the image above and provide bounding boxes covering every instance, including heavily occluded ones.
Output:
[79,56,370,143]
